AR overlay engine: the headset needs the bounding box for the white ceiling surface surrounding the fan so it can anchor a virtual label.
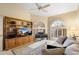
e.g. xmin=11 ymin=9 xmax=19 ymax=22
xmin=19 ymin=3 xmax=78 ymax=16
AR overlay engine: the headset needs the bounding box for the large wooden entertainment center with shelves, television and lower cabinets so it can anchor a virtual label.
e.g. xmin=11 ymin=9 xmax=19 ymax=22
xmin=3 ymin=16 xmax=33 ymax=50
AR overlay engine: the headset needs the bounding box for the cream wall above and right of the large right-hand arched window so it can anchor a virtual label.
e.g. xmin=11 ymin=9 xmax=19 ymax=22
xmin=49 ymin=11 xmax=79 ymax=36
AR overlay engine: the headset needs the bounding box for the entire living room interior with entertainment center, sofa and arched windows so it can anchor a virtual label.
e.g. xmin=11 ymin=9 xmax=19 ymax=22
xmin=0 ymin=3 xmax=79 ymax=55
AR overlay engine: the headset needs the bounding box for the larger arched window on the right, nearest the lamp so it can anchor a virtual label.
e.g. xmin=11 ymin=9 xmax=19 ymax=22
xmin=50 ymin=19 xmax=67 ymax=39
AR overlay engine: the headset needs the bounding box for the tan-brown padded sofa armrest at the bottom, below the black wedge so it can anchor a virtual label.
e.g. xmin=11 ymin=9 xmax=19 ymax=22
xmin=42 ymin=48 xmax=65 ymax=55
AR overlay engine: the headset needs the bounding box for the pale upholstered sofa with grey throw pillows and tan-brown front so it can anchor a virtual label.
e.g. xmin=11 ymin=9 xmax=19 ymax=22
xmin=42 ymin=37 xmax=79 ymax=55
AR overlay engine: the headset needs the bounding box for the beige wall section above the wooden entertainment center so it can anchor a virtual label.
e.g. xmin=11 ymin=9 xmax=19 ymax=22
xmin=0 ymin=3 xmax=31 ymax=20
